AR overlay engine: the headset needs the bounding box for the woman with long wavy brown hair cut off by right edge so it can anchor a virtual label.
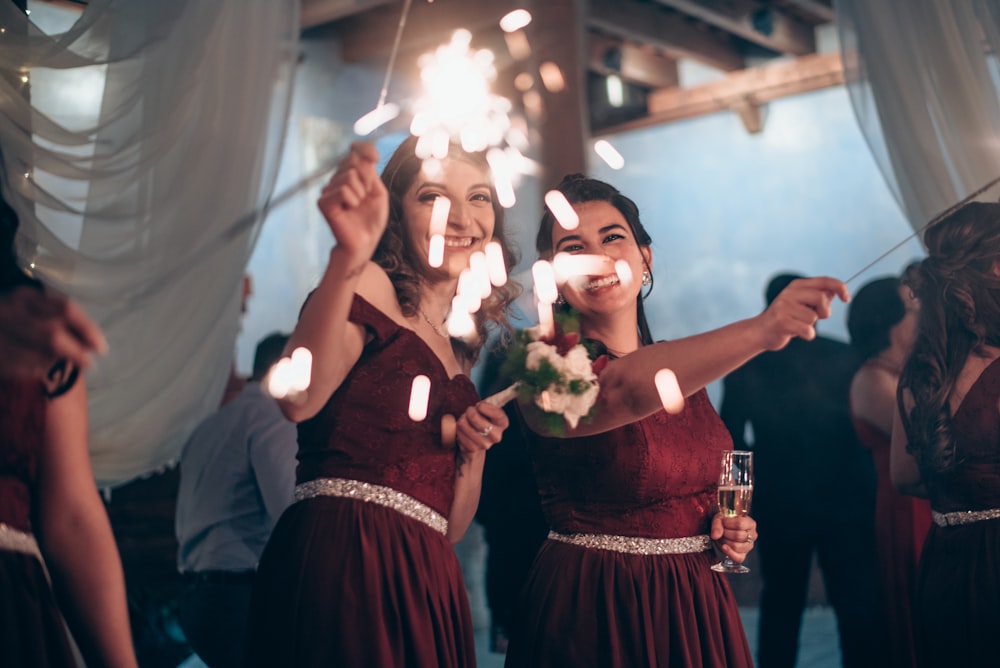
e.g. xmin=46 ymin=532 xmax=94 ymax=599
xmin=890 ymin=202 xmax=1000 ymax=666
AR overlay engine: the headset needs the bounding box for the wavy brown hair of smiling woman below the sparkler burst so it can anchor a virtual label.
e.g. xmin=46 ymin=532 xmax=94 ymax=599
xmin=372 ymin=136 xmax=521 ymax=362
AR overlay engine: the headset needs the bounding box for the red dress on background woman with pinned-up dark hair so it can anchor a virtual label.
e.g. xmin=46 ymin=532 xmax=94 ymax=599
xmin=851 ymin=386 xmax=931 ymax=668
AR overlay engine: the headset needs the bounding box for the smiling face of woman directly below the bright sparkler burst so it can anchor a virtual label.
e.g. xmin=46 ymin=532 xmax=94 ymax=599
xmin=402 ymin=157 xmax=496 ymax=279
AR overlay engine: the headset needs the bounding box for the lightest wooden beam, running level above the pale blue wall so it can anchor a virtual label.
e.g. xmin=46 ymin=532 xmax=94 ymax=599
xmin=600 ymin=53 xmax=844 ymax=134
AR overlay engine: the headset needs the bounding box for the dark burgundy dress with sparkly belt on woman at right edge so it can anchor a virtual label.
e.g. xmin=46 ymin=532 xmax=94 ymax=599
xmin=914 ymin=359 xmax=1000 ymax=667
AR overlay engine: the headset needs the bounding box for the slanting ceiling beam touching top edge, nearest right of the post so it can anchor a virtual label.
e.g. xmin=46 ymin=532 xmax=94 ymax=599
xmin=587 ymin=0 xmax=744 ymax=72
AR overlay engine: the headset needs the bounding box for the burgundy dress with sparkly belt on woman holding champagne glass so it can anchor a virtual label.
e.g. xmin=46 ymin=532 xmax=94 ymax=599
xmin=506 ymin=390 xmax=753 ymax=668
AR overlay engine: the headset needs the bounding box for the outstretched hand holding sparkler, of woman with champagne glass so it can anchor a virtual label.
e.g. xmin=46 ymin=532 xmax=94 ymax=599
xmin=757 ymin=276 xmax=850 ymax=350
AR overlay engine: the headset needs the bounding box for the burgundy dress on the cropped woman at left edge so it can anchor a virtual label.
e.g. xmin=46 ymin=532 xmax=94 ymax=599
xmin=0 ymin=380 xmax=77 ymax=667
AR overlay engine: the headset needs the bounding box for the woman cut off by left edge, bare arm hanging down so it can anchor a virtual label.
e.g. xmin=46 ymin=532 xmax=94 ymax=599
xmin=0 ymin=200 xmax=136 ymax=668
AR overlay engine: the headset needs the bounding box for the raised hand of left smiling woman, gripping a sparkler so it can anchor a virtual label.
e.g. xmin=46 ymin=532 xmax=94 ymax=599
xmin=317 ymin=142 xmax=389 ymax=260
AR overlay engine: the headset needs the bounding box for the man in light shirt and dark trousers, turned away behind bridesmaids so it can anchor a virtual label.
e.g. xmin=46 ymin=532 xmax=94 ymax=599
xmin=175 ymin=333 xmax=297 ymax=668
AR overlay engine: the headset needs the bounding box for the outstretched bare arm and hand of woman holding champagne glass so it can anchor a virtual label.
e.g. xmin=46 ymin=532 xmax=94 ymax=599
xmin=522 ymin=278 xmax=848 ymax=437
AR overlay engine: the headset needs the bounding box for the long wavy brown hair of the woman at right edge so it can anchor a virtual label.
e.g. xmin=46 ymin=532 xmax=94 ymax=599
xmin=898 ymin=202 xmax=1000 ymax=471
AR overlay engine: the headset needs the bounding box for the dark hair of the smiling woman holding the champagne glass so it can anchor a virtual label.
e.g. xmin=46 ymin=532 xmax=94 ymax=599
xmin=535 ymin=174 xmax=653 ymax=346
